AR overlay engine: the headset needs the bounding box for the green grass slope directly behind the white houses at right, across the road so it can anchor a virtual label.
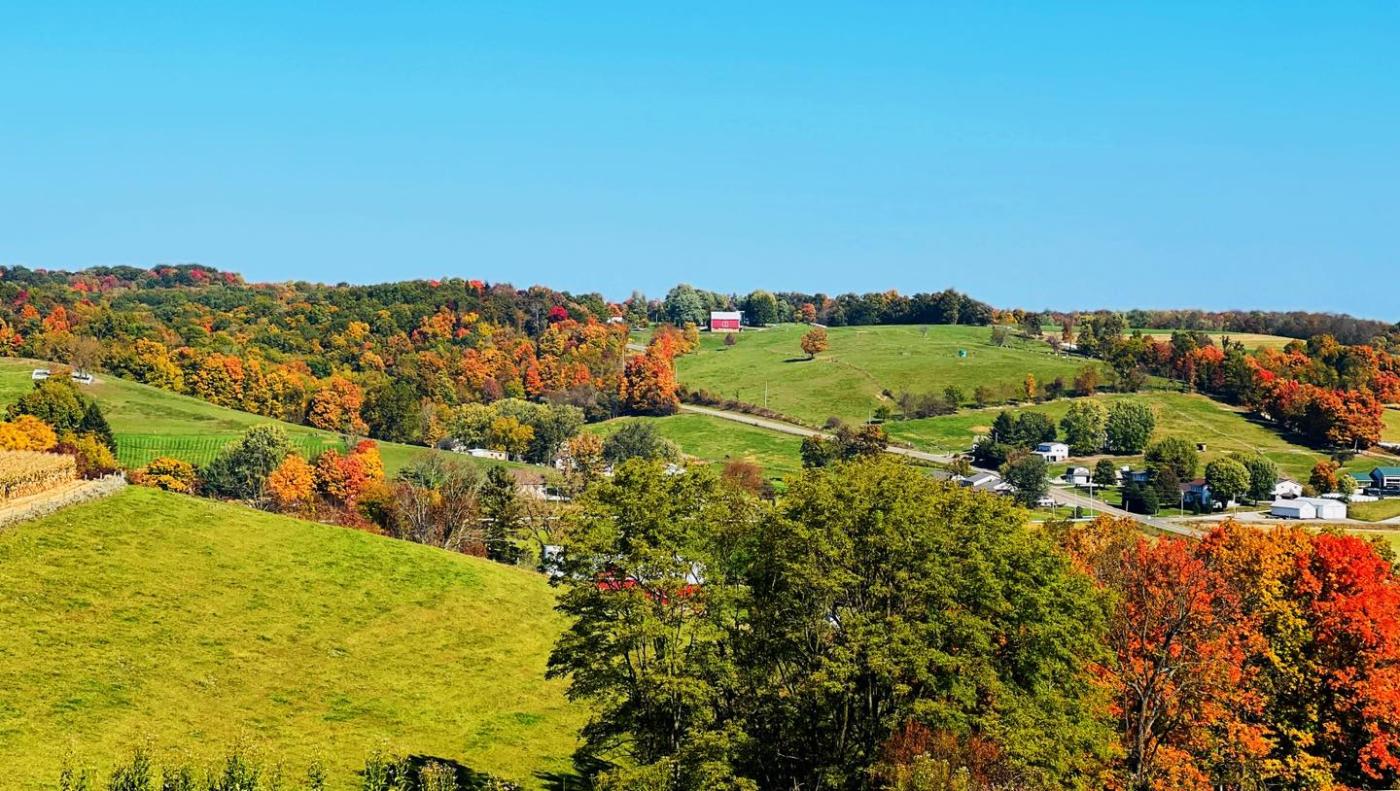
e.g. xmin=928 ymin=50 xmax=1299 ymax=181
xmin=885 ymin=391 xmax=1380 ymax=482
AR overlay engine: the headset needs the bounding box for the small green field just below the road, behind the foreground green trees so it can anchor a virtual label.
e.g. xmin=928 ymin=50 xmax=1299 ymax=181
xmin=585 ymin=412 xmax=802 ymax=479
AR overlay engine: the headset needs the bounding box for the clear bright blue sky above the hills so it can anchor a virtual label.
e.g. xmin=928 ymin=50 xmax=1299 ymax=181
xmin=0 ymin=0 xmax=1400 ymax=321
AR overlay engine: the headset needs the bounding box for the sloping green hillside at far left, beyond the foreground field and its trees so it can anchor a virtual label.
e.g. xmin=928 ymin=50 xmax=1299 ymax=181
xmin=0 ymin=360 xmax=448 ymax=473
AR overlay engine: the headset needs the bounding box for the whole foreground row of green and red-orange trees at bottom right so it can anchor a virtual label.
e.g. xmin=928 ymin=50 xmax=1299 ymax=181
xmin=550 ymin=459 xmax=1400 ymax=791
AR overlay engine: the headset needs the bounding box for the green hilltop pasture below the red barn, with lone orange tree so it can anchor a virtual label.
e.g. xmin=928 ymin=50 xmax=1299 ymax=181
xmin=676 ymin=325 xmax=1098 ymax=423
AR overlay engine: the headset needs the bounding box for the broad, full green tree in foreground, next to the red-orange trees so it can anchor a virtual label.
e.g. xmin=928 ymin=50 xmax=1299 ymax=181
xmin=739 ymin=459 xmax=1106 ymax=788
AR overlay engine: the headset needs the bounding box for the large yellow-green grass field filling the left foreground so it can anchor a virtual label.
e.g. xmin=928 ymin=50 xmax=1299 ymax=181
xmin=0 ymin=487 xmax=584 ymax=790
